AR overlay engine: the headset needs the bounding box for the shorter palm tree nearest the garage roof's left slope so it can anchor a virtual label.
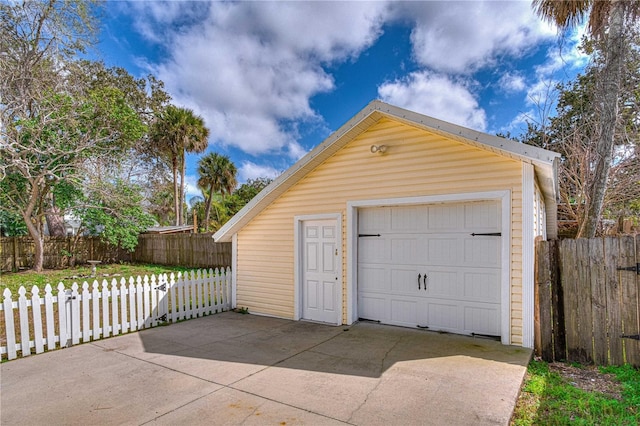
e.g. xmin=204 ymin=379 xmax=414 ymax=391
xmin=198 ymin=152 xmax=238 ymax=229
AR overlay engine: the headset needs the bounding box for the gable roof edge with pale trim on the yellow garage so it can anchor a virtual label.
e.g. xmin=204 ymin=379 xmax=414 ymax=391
xmin=213 ymin=100 xmax=560 ymax=242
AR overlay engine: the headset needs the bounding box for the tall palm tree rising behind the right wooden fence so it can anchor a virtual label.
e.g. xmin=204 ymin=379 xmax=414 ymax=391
xmin=533 ymin=0 xmax=640 ymax=238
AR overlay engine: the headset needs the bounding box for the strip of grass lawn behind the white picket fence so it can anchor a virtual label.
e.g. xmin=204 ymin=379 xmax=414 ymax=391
xmin=0 ymin=263 xmax=193 ymax=295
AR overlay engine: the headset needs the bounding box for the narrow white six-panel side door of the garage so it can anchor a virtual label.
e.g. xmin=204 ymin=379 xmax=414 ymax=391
xmin=302 ymin=219 xmax=342 ymax=324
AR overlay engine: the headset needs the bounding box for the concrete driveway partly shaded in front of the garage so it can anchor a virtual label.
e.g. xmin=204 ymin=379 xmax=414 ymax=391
xmin=0 ymin=312 xmax=531 ymax=425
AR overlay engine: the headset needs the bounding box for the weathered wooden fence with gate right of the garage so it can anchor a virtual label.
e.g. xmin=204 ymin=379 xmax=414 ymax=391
xmin=535 ymin=235 xmax=640 ymax=367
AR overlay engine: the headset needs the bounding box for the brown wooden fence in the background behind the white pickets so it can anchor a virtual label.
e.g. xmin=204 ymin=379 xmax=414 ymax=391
xmin=0 ymin=234 xmax=231 ymax=272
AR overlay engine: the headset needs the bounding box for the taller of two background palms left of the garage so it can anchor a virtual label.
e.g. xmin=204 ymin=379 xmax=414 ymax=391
xmin=151 ymin=105 xmax=209 ymax=225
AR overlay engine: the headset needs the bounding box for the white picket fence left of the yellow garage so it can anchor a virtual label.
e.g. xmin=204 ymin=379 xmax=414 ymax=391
xmin=0 ymin=268 xmax=232 ymax=360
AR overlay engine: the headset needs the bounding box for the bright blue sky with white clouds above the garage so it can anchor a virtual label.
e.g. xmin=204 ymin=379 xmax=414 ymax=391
xmin=95 ymin=1 xmax=588 ymax=199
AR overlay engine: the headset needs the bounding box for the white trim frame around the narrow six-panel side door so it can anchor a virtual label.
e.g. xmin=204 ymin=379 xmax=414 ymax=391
xmin=293 ymin=213 xmax=344 ymax=325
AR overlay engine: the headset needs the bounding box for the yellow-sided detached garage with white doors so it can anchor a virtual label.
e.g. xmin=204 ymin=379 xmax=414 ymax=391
xmin=214 ymin=101 xmax=559 ymax=347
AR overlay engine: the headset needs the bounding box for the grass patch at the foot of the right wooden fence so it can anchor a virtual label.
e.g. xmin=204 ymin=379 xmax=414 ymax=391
xmin=511 ymin=361 xmax=640 ymax=426
